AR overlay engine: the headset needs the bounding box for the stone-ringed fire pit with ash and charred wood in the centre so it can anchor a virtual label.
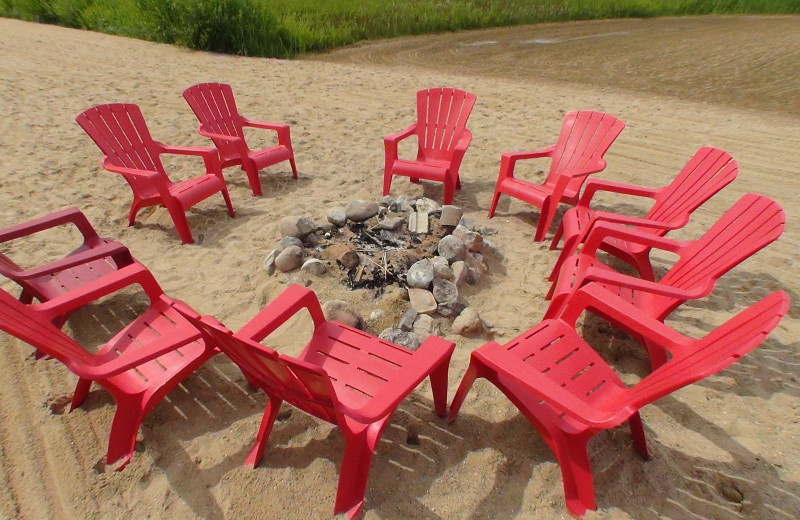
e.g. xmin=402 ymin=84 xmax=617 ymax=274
xmin=264 ymin=196 xmax=502 ymax=348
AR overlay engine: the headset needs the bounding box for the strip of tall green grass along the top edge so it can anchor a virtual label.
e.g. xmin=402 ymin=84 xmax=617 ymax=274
xmin=0 ymin=0 xmax=800 ymax=57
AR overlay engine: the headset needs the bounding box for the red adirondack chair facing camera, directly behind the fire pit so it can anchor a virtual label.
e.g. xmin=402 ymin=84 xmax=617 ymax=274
xmin=383 ymin=87 xmax=476 ymax=204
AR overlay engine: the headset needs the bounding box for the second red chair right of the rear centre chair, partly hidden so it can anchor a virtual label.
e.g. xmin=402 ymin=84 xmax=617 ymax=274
xmin=550 ymin=147 xmax=739 ymax=280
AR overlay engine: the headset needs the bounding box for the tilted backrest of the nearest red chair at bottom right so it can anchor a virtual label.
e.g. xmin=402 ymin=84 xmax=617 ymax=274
xmin=628 ymin=291 xmax=789 ymax=408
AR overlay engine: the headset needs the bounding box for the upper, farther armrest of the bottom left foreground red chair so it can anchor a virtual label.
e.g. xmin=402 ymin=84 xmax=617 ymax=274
xmin=31 ymin=263 xmax=164 ymax=321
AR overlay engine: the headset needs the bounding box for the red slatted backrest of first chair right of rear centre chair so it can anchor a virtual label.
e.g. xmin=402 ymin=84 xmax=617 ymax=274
xmin=545 ymin=110 xmax=625 ymax=193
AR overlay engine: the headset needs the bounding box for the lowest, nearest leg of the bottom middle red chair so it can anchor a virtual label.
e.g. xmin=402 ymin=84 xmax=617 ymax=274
xmin=333 ymin=417 xmax=388 ymax=519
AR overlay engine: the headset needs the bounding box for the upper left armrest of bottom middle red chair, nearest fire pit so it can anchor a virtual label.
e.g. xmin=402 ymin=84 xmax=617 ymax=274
xmin=234 ymin=285 xmax=325 ymax=342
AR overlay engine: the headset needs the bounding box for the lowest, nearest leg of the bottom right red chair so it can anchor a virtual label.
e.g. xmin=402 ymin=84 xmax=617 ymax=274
xmin=553 ymin=433 xmax=597 ymax=516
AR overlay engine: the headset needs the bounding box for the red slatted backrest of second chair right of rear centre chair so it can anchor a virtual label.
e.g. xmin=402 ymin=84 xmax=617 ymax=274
xmin=640 ymin=146 xmax=739 ymax=228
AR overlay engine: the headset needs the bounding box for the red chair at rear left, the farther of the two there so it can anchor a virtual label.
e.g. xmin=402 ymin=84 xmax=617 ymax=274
xmin=183 ymin=83 xmax=297 ymax=196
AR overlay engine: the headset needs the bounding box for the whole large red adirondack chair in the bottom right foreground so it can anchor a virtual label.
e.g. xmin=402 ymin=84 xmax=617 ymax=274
xmin=449 ymin=283 xmax=789 ymax=515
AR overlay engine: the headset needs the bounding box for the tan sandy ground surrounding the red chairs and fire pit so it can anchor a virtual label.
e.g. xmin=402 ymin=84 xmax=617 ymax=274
xmin=0 ymin=17 xmax=800 ymax=519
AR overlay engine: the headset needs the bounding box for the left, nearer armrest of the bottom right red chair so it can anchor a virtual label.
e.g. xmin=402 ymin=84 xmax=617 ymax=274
xmin=472 ymin=341 xmax=636 ymax=429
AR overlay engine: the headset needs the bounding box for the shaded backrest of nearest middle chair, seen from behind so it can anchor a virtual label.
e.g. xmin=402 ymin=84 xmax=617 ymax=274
xmin=184 ymin=306 xmax=339 ymax=424
